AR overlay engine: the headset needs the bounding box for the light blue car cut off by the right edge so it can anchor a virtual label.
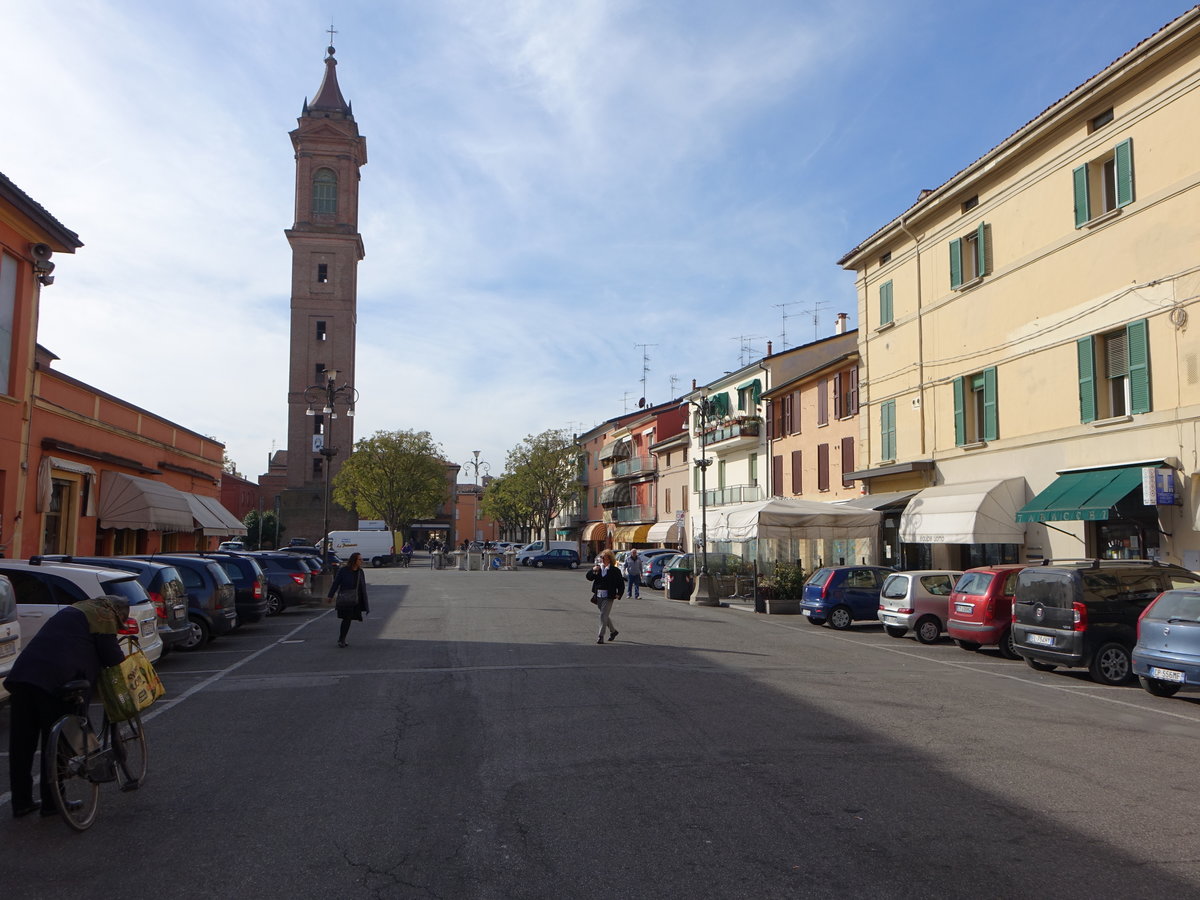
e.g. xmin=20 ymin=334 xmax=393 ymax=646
xmin=1133 ymin=588 xmax=1200 ymax=697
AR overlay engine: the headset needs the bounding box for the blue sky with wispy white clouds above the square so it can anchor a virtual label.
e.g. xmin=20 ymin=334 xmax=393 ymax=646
xmin=0 ymin=0 xmax=1190 ymax=478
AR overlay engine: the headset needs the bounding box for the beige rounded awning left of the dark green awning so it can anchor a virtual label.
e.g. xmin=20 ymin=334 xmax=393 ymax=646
xmin=900 ymin=478 xmax=1027 ymax=544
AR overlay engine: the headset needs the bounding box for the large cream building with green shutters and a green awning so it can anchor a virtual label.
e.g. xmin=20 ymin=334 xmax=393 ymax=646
xmin=840 ymin=10 xmax=1200 ymax=569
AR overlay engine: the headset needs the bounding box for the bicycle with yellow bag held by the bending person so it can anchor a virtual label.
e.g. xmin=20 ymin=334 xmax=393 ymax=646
xmin=42 ymin=679 xmax=146 ymax=832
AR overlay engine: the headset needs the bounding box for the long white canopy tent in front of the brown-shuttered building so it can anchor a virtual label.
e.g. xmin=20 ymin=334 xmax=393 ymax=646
xmin=695 ymin=497 xmax=880 ymax=542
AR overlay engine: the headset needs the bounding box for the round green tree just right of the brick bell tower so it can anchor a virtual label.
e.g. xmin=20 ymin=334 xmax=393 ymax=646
xmin=334 ymin=431 xmax=449 ymax=547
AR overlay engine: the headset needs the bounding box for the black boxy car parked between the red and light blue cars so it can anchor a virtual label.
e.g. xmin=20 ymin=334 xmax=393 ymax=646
xmin=1012 ymin=559 xmax=1200 ymax=684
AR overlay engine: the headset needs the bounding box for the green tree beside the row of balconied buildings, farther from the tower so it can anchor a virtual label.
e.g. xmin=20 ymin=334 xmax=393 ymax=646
xmin=505 ymin=428 xmax=583 ymax=540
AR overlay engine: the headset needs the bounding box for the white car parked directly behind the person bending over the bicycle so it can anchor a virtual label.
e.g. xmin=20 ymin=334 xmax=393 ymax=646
xmin=0 ymin=557 xmax=162 ymax=662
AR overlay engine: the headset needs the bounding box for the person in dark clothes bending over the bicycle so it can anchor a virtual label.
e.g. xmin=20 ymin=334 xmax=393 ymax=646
xmin=4 ymin=594 xmax=130 ymax=818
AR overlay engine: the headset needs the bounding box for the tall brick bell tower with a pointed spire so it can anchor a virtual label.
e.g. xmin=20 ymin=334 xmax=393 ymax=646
xmin=280 ymin=47 xmax=367 ymax=540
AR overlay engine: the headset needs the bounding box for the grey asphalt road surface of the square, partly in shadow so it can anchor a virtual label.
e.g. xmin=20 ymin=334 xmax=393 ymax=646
xmin=0 ymin=568 xmax=1200 ymax=900
